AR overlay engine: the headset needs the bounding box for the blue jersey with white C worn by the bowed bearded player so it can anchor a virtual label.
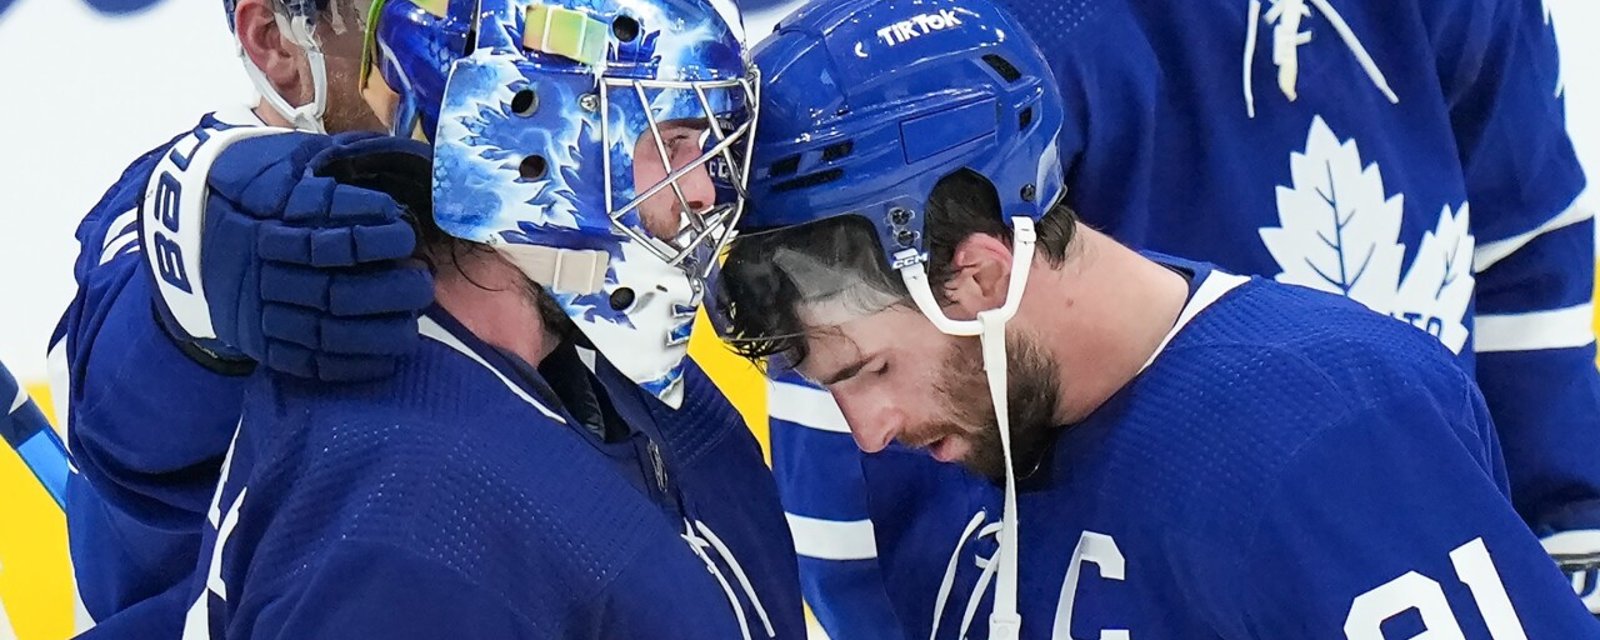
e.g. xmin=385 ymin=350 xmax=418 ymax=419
xmin=902 ymin=262 xmax=1600 ymax=640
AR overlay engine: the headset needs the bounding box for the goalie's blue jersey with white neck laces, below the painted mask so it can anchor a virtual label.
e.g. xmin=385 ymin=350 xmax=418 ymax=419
xmin=184 ymin=309 xmax=805 ymax=638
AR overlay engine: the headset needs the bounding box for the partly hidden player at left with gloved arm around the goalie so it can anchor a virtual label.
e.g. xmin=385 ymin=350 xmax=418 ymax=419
xmin=51 ymin=0 xmax=432 ymax=626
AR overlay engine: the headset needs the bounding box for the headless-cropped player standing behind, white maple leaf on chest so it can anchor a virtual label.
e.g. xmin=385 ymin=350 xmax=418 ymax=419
xmin=770 ymin=0 xmax=1600 ymax=637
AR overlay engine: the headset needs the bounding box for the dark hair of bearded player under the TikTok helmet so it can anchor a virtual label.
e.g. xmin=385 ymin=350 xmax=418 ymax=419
xmin=717 ymin=170 xmax=1078 ymax=365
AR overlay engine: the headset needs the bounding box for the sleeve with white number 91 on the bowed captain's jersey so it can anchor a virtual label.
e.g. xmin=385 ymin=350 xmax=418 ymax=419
xmin=1192 ymin=374 xmax=1600 ymax=640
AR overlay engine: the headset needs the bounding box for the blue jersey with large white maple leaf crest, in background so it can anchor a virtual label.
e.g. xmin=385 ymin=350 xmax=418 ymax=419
xmin=1088 ymin=0 xmax=1600 ymax=533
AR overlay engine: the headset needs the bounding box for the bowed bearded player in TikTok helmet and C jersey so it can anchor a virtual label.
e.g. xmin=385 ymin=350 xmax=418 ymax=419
xmin=718 ymin=0 xmax=1600 ymax=638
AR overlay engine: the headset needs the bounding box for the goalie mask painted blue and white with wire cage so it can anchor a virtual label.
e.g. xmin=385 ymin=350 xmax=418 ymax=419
xmin=363 ymin=0 xmax=760 ymax=406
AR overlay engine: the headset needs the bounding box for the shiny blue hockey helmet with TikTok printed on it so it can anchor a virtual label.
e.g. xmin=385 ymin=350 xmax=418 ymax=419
xmin=741 ymin=0 xmax=1064 ymax=267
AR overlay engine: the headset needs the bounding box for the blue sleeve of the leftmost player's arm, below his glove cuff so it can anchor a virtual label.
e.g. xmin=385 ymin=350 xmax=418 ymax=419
xmin=51 ymin=117 xmax=248 ymax=619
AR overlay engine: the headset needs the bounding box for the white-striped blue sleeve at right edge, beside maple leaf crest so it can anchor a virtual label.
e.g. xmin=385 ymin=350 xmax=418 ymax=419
xmin=1440 ymin=0 xmax=1600 ymax=531
